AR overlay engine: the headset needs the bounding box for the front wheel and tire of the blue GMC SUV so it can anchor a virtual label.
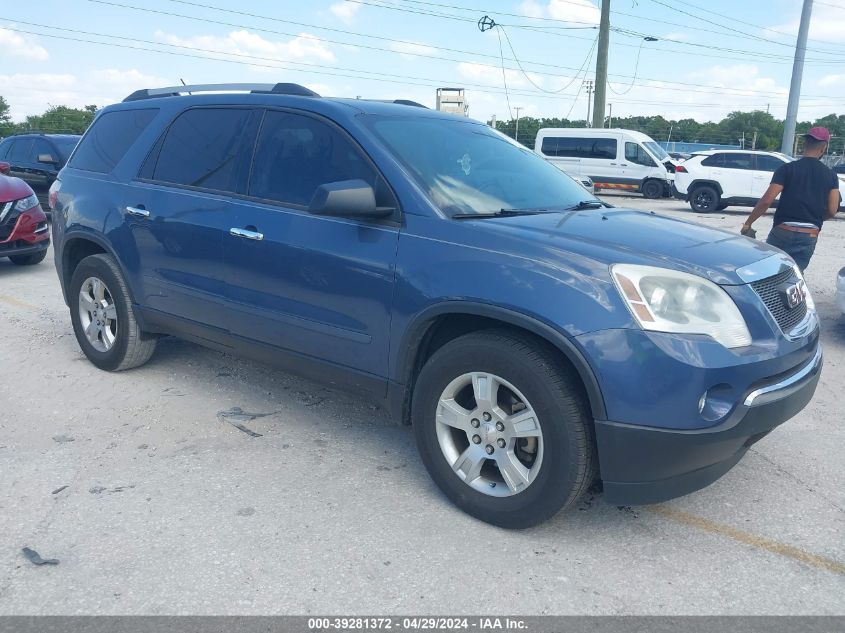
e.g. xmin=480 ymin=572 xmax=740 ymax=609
xmin=411 ymin=330 xmax=596 ymax=528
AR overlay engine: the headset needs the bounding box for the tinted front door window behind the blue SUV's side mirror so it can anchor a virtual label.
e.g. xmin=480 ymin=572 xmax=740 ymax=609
xmin=249 ymin=111 xmax=380 ymax=206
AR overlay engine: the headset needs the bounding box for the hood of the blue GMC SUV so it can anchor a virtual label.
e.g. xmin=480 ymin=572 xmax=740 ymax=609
xmin=472 ymin=208 xmax=780 ymax=285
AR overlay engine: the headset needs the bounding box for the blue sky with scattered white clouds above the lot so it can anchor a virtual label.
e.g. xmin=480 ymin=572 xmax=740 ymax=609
xmin=0 ymin=0 xmax=845 ymax=133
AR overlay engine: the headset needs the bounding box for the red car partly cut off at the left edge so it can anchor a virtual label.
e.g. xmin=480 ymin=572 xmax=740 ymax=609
xmin=0 ymin=162 xmax=50 ymax=266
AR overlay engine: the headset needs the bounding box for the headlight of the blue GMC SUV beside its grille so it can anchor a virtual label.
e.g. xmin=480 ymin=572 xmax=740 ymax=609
xmin=611 ymin=264 xmax=751 ymax=347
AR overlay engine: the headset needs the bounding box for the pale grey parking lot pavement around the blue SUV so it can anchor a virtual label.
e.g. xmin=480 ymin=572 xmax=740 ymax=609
xmin=0 ymin=196 xmax=845 ymax=615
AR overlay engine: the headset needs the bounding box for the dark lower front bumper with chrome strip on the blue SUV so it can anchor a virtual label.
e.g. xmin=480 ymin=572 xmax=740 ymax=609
xmin=596 ymin=345 xmax=822 ymax=505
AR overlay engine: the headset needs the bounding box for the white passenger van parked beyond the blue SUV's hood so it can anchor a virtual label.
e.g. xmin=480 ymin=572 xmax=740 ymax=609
xmin=534 ymin=127 xmax=675 ymax=198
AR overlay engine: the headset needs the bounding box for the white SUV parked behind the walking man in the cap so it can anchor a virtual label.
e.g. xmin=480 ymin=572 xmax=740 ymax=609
xmin=673 ymin=150 xmax=845 ymax=213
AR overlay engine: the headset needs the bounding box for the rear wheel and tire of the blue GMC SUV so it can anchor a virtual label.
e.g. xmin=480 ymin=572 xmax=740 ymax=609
xmin=68 ymin=254 xmax=156 ymax=371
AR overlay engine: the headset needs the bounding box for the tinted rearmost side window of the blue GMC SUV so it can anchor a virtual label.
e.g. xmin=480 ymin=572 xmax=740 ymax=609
xmin=70 ymin=109 xmax=158 ymax=174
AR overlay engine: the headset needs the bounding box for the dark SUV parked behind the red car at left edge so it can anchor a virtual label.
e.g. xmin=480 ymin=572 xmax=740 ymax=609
xmin=0 ymin=133 xmax=82 ymax=213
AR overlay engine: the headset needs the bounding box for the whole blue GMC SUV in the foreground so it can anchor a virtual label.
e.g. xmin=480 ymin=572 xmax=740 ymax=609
xmin=51 ymin=84 xmax=822 ymax=528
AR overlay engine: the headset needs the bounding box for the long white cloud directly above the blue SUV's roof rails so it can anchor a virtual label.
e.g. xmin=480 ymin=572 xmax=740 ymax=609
xmin=155 ymin=29 xmax=335 ymax=72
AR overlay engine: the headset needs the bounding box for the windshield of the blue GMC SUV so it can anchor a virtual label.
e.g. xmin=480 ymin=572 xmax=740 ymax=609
xmin=368 ymin=116 xmax=597 ymax=217
